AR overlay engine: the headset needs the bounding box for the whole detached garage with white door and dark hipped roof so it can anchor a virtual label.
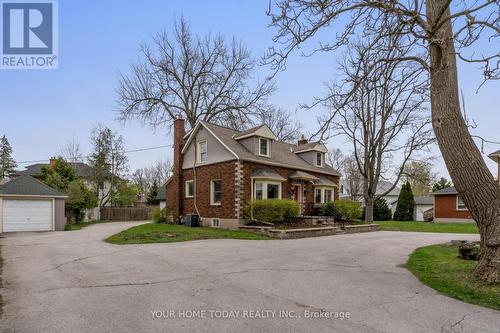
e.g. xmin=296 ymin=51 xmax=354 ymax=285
xmin=0 ymin=176 xmax=66 ymax=232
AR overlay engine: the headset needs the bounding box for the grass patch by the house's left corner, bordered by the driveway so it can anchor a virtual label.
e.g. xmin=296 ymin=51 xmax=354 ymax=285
xmin=106 ymin=223 xmax=272 ymax=244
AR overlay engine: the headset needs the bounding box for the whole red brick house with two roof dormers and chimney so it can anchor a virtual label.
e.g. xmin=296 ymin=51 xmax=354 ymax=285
xmin=165 ymin=118 xmax=340 ymax=228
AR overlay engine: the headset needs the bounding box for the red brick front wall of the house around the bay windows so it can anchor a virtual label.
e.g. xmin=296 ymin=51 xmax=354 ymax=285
xmin=242 ymin=162 xmax=339 ymax=215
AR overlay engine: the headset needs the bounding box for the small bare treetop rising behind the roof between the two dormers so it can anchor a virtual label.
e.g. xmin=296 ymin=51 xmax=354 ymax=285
xmin=258 ymin=106 xmax=301 ymax=143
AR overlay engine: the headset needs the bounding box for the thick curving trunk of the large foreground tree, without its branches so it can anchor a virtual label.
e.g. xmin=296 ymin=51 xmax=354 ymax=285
xmin=427 ymin=0 xmax=500 ymax=282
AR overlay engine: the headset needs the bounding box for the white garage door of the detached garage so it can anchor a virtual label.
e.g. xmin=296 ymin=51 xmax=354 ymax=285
xmin=3 ymin=200 xmax=52 ymax=232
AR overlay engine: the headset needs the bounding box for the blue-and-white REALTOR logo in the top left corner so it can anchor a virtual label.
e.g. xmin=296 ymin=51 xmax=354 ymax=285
xmin=0 ymin=0 xmax=58 ymax=69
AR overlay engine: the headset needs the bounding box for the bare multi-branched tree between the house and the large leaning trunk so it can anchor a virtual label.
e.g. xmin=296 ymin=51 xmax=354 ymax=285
xmin=318 ymin=34 xmax=432 ymax=222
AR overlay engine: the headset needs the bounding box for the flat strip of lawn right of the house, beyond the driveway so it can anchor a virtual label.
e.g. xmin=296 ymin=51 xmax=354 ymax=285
xmin=374 ymin=221 xmax=479 ymax=234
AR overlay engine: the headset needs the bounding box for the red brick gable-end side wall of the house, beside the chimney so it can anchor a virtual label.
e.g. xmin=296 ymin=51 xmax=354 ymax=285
xmin=180 ymin=161 xmax=236 ymax=219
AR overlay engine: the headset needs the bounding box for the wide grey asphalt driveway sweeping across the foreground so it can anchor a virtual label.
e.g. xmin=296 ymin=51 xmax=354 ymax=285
xmin=0 ymin=223 xmax=500 ymax=333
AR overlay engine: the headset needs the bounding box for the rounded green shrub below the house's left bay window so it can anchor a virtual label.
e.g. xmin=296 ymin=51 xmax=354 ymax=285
xmin=243 ymin=199 xmax=300 ymax=223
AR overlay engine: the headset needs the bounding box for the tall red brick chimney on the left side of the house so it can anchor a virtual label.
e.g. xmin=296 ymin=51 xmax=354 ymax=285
xmin=165 ymin=114 xmax=185 ymax=219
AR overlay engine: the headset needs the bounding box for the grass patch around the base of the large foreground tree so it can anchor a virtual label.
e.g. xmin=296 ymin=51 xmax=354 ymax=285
xmin=408 ymin=245 xmax=500 ymax=310
